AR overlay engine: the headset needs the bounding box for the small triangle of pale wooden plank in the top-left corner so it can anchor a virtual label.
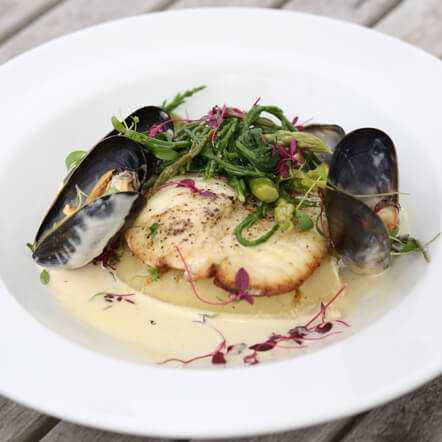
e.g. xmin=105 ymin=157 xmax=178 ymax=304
xmin=0 ymin=0 xmax=62 ymax=41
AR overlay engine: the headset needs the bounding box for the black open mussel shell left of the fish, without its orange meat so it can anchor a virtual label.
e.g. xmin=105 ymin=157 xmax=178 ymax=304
xmin=33 ymin=136 xmax=154 ymax=268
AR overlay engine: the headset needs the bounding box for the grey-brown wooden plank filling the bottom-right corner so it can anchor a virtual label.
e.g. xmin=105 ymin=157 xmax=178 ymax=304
xmin=342 ymin=376 xmax=442 ymax=442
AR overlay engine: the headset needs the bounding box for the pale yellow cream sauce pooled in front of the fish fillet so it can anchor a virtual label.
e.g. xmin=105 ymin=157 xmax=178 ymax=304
xmin=45 ymin=250 xmax=376 ymax=367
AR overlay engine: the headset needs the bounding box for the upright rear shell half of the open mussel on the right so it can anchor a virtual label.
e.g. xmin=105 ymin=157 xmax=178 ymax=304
xmin=328 ymin=128 xmax=398 ymax=210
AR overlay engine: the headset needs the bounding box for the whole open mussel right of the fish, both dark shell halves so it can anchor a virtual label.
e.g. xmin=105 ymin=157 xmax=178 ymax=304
xmin=324 ymin=128 xmax=399 ymax=273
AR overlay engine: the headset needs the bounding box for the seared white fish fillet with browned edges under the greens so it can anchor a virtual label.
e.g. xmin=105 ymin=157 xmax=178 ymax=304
xmin=126 ymin=176 xmax=328 ymax=295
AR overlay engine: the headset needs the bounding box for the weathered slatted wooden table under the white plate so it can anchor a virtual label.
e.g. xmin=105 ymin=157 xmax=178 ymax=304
xmin=0 ymin=0 xmax=442 ymax=442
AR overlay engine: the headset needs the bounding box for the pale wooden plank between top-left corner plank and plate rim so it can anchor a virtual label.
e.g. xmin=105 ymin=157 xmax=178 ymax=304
xmin=0 ymin=0 xmax=176 ymax=63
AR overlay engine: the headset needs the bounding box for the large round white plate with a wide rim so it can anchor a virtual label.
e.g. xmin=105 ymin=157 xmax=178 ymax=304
xmin=0 ymin=9 xmax=442 ymax=438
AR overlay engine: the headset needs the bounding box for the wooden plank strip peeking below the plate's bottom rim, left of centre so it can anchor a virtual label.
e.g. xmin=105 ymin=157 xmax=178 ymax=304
xmin=41 ymin=422 xmax=171 ymax=442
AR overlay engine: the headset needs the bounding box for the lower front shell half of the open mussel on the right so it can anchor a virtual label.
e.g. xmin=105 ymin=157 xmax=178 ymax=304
xmin=324 ymin=190 xmax=391 ymax=274
